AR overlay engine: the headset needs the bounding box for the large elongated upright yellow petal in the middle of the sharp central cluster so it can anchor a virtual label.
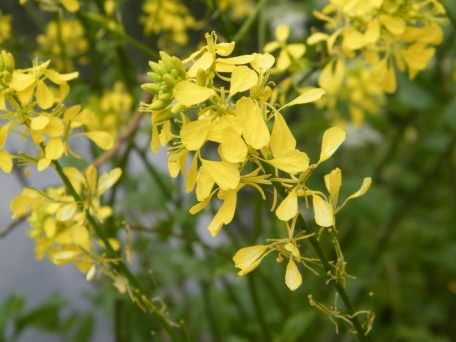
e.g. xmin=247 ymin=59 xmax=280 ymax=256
xmin=236 ymin=97 xmax=271 ymax=150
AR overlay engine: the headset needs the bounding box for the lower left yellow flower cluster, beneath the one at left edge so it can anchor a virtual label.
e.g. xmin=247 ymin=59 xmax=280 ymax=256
xmin=11 ymin=166 xmax=122 ymax=279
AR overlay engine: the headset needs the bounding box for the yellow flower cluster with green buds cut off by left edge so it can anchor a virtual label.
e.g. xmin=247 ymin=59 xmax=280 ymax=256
xmin=0 ymin=51 xmax=113 ymax=173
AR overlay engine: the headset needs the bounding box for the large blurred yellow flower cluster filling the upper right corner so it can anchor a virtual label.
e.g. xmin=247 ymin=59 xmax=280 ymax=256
xmin=307 ymin=0 xmax=446 ymax=124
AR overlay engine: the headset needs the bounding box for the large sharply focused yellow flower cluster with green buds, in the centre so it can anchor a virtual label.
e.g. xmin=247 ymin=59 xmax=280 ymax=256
xmin=142 ymin=34 xmax=371 ymax=290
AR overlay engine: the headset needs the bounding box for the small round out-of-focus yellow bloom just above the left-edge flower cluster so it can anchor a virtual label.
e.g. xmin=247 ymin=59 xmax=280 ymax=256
xmin=37 ymin=19 xmax=88 ymax=71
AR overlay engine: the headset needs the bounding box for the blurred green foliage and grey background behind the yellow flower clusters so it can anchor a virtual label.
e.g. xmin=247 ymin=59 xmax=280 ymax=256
xmin=0 ymin=0 xmax=456 ymax=342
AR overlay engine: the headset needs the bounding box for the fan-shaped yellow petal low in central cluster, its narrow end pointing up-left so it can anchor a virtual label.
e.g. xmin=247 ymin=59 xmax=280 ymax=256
xmin=203 ymin=160 xmax=241 ymax=190
